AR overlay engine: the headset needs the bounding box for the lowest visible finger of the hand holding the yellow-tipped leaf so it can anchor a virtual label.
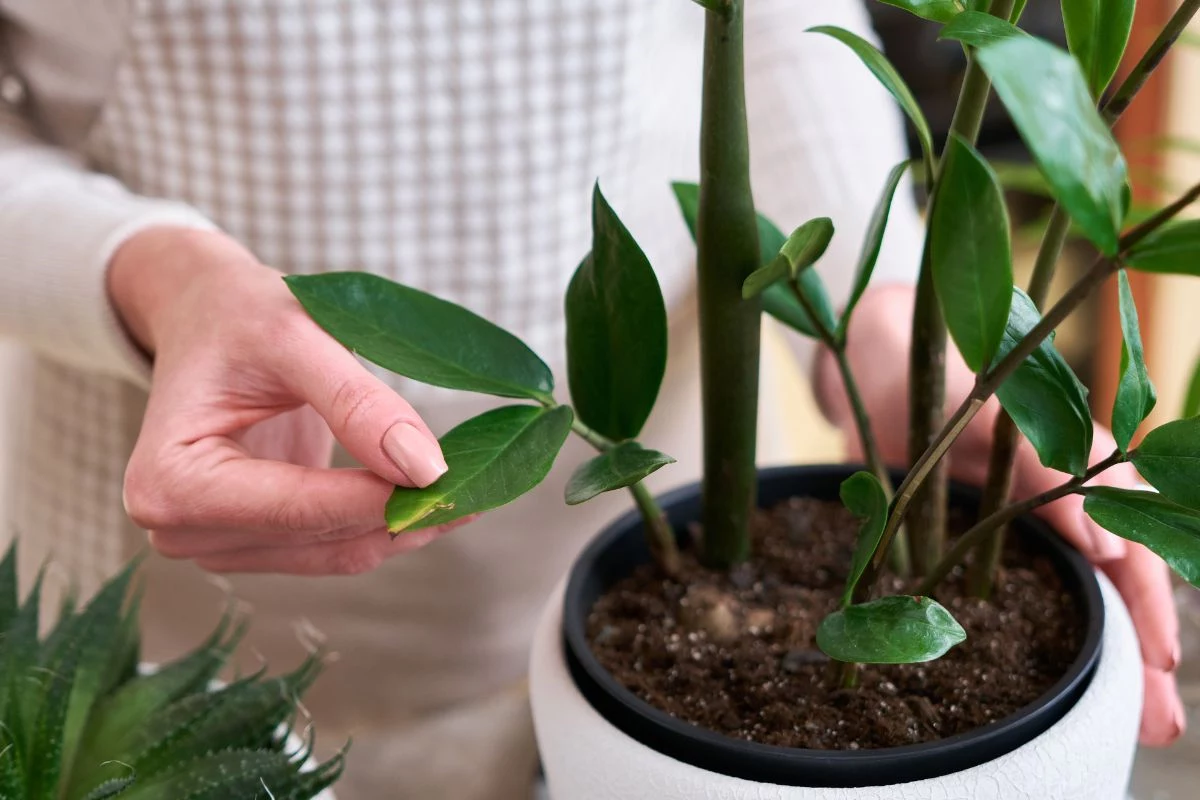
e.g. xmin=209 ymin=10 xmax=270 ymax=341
xmin=197 ymin=525 xmax=457 ymax=576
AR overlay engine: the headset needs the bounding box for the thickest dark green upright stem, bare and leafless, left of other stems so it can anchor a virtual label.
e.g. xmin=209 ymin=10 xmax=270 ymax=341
xmin=696 ymin=0 xmax=762 ymax=567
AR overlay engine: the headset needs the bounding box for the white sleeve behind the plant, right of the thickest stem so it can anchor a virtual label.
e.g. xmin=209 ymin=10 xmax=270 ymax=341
xmin=745 ymin=0 xmax=923 ymax=362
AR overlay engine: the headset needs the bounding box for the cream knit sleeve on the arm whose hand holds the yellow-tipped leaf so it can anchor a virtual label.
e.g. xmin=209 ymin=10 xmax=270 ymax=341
xmin=0 ymin=94 xmax=212 ymax=386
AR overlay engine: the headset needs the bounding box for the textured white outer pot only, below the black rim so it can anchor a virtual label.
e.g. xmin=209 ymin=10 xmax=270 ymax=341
xmin=529 ymin=563 xmax=1142 ymax=800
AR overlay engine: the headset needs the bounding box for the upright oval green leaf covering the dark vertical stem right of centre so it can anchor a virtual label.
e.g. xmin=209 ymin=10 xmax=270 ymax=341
xmin=929 ymin=134 xmax=1013 ymax=372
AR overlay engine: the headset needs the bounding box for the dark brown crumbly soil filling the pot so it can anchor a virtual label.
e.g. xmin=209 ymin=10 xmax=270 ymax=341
xmin=588 ymin=499 xmax=1084 ymax=750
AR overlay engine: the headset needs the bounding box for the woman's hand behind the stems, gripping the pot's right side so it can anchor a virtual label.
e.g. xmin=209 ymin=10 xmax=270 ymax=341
xmin=814 ymin=287 xmax=1186 ymax=745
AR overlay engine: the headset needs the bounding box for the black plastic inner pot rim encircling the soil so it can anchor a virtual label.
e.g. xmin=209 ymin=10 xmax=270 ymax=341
xmin=563 ymin=464 xmax=1104 ymax=788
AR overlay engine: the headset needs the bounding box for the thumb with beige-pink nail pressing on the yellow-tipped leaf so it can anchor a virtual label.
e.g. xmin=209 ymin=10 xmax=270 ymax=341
xmin=282 ymin=325 xmax=446 ymax=487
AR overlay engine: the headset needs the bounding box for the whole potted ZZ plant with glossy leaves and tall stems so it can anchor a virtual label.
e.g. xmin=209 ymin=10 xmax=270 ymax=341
xmin=287 ymin=0 xmax=1200 ymax=685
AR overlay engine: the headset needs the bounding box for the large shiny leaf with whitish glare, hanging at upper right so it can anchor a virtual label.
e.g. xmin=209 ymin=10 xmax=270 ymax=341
xmin=976 ymin=36 xmax=1126 ymax=255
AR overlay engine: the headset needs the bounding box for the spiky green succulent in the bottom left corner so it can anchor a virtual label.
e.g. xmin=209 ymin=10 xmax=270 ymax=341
xmin=0 ymin=545 xmax=343 ymax=800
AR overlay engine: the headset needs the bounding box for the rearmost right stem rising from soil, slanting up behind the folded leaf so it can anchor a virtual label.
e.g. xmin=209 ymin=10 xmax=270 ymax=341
xmin=967 ymin=204 xmax=1070 ymax=599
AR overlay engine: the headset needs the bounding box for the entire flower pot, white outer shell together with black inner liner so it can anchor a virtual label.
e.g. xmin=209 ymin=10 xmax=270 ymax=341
xmin=530 ymin=465 xmax=1142 ymax=800
